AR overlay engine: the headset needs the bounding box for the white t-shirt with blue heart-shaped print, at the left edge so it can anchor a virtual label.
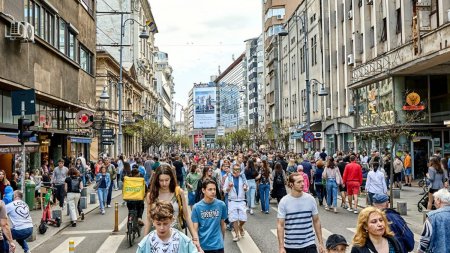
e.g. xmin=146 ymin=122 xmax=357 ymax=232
xmin=6 ymin=200 xmax=33 ymax=230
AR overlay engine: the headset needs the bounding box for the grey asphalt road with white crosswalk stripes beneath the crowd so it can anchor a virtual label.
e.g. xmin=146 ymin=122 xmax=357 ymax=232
xmin=29 ymin=190 xmax=421 ymax=253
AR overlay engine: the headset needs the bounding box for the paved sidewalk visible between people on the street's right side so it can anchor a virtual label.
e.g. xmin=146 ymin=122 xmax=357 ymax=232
xmin=358 ymin=180 xmax=426 ymax=234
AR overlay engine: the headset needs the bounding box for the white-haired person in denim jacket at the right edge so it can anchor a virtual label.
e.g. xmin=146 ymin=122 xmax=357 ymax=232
xmin=417 ymin=188 xmax=450 ymax=253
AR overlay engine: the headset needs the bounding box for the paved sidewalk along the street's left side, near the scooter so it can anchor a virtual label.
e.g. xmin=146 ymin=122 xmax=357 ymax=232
xmin=28 ymin=184 xmax=122 ymax=251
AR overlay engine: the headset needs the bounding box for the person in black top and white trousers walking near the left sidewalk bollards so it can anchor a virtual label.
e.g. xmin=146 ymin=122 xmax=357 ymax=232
xmin=64 ymin=167 xmax=84 ymax=227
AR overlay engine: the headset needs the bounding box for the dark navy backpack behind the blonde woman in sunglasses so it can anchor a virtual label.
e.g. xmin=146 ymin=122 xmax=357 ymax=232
xmin=386 ymin=209 xmax=414 ymax=253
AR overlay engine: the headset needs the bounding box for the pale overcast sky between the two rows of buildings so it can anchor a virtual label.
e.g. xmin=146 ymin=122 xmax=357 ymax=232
xmin=149 ymin=0 xmax=262 ymax=110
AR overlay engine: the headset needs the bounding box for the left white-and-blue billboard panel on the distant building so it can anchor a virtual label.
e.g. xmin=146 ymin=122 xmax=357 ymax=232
xmin=194 ymin=87 xmax=216 ymax=128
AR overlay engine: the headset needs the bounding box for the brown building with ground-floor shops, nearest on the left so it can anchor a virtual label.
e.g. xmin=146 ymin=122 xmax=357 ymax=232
xmin=0 ymin=0 xmax=96 ymax=170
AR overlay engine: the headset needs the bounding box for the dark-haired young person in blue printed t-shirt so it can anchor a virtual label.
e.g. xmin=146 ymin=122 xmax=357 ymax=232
xmin=191 ymin=178 xmax=227 ymax=253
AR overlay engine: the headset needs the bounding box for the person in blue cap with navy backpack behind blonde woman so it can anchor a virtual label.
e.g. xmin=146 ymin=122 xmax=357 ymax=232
xmin=372 ymin=194 xmax=414 ymax=253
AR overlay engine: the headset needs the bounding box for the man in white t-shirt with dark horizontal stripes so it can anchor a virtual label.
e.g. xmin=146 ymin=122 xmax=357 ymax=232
xmin=277 ymin=172 xmax=325 ymax=253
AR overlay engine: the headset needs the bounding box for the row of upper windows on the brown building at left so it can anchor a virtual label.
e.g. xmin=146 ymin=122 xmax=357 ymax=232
xmin=24 ymin=0 xmax=94 ymax=74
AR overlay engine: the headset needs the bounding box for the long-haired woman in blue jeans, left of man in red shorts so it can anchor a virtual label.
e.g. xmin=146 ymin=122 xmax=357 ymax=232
xmin=322 ymin=157 xmax=342 ymax=213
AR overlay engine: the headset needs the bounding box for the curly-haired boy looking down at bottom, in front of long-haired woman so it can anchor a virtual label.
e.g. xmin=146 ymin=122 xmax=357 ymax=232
xmin=136 ymin=201 xmax=198 ymax=253
